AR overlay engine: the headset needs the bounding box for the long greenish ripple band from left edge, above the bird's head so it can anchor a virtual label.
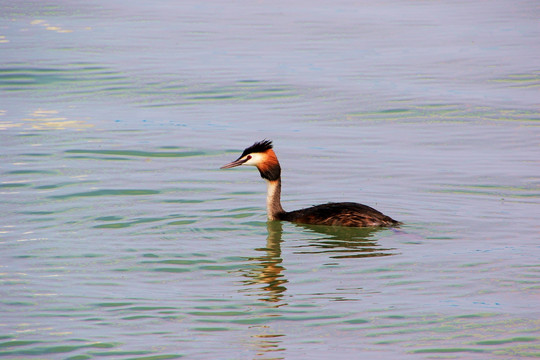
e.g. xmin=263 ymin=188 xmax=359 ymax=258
xmin=0 ymin=63 xmax=299 ymax=107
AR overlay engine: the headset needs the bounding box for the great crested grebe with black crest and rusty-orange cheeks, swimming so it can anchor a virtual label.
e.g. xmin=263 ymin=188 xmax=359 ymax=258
xmin=221 ymin=140 xmax=399 ymax=227
